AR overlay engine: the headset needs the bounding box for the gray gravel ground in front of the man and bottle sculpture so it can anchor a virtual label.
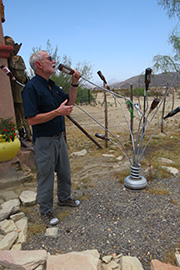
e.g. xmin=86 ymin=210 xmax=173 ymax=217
xmin=23 ymin=177 xmax=180 ymax=270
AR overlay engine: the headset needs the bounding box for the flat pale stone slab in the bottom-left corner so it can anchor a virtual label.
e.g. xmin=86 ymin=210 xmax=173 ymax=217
xmin=0 ymin=250 xmax=47 ymax=270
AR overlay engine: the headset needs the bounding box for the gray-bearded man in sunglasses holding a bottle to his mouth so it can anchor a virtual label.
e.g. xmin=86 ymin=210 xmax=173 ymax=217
xmin=22 ymin=51 xmax=81 ymax=225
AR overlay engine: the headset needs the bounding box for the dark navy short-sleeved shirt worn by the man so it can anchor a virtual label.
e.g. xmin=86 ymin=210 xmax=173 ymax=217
xmin=22 ymin=75 xmax=69 ymax=142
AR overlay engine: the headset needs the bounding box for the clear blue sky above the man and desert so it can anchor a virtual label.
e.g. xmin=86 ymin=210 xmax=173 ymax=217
xmin=2 ymin=0 xmax=177 ymax=82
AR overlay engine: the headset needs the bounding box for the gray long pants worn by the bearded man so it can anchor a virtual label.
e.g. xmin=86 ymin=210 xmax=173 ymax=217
xmin=34 ymin=135 xmax=71 ymax=214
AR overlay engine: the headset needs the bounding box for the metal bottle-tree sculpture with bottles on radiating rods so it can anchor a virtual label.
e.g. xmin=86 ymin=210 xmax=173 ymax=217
xmin=58 ymin=64 xmax=180 ymax=190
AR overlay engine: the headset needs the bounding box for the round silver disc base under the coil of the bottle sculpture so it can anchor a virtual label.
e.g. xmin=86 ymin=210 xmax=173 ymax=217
xmin=124 ymin=175 xmax=147 ymax=190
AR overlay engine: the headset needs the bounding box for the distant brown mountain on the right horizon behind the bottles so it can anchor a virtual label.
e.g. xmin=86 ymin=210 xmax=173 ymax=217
xmin=110 ymin=72 xmax=180 ymax=89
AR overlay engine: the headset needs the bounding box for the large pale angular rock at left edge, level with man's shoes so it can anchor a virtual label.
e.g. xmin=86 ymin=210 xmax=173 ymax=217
xmin=0 ymin=199 xmax=20 ymax=221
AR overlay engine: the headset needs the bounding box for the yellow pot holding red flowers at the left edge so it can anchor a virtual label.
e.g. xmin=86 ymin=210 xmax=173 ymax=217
xmin=0 ymin=135 xmax=21 ymax=162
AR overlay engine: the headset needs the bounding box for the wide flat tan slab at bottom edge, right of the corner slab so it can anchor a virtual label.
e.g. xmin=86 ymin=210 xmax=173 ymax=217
xmin=47 ymin=250 xmax=100 ymax=270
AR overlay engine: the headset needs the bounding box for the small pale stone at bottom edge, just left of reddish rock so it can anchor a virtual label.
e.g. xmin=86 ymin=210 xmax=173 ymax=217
xmin=120 ymin=256 xmax=143 ymax=270
